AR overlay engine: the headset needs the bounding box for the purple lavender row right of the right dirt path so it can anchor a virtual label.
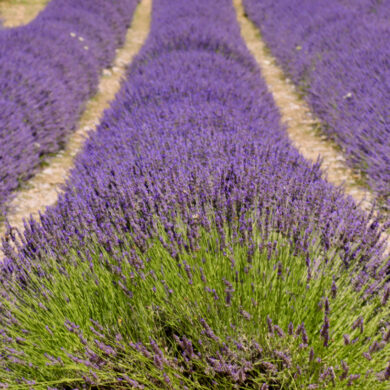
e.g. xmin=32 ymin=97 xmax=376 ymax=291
xmin=244 ymin=0 xmax=390 ymax=209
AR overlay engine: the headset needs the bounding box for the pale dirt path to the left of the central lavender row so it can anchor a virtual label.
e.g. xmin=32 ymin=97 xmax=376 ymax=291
xmin=0 ymin=0 xmax=152 ymax=241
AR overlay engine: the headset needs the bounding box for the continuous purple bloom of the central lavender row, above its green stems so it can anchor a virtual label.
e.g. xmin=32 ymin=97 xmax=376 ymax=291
xmin=4 ymin=0 xmax=382 ymax=276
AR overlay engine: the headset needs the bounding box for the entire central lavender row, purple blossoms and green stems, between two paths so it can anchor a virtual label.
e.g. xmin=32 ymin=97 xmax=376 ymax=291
xmin=0 ymin=0 xmax=390 ymax=390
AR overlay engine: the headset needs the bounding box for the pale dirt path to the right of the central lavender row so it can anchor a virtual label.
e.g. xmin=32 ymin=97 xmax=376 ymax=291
xmin=234 ymin=0 xmax=373 ymax=209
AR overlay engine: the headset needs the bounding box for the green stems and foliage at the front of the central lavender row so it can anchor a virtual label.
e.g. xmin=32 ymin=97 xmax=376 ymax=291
xmin=0 ymin=215 xmax=390 ymax=389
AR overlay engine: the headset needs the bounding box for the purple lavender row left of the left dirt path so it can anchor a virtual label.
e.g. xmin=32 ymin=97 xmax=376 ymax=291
xmin=0 ymin=0 xmax=137 ymax=217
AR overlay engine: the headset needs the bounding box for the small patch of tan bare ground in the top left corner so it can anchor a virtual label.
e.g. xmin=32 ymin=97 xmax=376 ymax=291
xmin=0 ymin=0 xmax=49 ymax=27
